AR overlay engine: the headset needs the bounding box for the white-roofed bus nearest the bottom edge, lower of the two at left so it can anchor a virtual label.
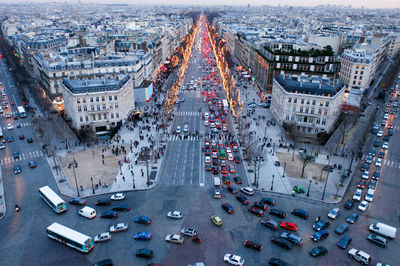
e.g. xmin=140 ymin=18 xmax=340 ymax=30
xmin=46 ymin=223 xmax=94 ymax=253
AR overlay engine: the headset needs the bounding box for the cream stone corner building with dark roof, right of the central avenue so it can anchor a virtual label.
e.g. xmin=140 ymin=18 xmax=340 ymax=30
xmin=271 ymin=75 xmax=345 ymax=137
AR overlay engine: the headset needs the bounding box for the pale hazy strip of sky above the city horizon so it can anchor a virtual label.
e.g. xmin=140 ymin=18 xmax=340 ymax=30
xmin=0 ymin=0 xmax=400 ymax=8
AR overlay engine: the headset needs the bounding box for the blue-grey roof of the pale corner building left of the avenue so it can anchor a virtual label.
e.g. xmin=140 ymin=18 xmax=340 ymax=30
xmin=63 ymin=75 xmax=131 ymax=94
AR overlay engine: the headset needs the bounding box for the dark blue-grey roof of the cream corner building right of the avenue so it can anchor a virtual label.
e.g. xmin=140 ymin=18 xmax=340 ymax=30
xmin=275 ymin=75 xmax=344 ymax=97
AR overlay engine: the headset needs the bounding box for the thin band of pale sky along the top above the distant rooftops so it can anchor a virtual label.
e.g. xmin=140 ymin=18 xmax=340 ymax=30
xmin=0 ymin=0 xmax=400 ymax=9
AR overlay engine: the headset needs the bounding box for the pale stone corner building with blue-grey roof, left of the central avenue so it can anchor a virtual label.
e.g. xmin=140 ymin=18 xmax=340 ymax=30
xmin=61 ymin=75 xmax=135 ymax=135
